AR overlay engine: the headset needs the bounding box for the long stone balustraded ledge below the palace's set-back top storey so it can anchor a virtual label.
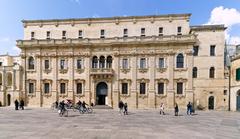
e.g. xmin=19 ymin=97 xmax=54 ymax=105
xmin=17 ymin=34 xmax=197 ymax=48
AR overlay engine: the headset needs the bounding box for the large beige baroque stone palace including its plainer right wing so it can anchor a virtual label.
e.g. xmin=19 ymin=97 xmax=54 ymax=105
xmin=0 ymin=14 xmax=229 ymax=110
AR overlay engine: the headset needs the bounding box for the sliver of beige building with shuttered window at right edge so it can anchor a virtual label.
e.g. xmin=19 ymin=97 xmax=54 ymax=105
xmin=230 ymin=45 xmax=240 ymax=111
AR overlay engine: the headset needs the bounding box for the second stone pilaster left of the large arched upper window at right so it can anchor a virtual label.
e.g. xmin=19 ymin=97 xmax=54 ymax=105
xmin=148 ymin=56 xmax=156 ymax=108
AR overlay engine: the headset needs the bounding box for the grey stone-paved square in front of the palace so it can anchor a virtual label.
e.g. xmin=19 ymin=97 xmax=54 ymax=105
xmin=0 ymin=107 xmax=240 ymax=139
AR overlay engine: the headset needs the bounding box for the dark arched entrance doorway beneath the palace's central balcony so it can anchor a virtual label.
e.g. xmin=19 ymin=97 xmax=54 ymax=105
xmin=96 ymin=82 xmax=108 ymax=105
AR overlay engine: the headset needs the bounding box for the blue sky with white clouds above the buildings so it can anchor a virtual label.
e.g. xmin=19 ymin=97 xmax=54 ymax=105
xmin=0 ymin=0 xmax=240 ymax=55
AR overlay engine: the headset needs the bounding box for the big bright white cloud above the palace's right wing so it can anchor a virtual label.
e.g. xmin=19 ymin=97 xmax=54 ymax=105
xmin=206 ymin=6 xmax=240 ymax=44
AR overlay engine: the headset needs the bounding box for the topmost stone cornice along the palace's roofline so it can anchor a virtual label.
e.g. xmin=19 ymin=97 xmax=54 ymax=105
xmin=22 ymin=14 xmax=191 ymax=27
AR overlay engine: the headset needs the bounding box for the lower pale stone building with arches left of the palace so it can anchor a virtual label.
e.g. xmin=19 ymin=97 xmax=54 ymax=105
xmin=0 ymin=54 xmax=23 ymax=106
